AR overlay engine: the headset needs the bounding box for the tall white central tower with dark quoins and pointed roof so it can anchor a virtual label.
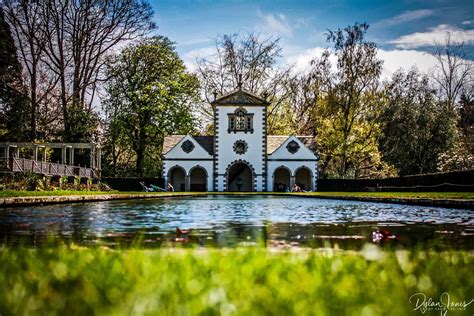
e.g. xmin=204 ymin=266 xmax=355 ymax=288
xmin=211 ymin=84 xmax=270 ymax=192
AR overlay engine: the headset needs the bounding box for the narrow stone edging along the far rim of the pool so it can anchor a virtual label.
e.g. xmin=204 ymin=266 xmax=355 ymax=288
xmin=0 ymin=192 xmax=474 ymax=210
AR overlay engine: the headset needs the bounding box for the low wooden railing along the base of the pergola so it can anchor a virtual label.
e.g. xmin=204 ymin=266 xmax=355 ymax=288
xmin=0 ymin=157 xmax=95 ymax=178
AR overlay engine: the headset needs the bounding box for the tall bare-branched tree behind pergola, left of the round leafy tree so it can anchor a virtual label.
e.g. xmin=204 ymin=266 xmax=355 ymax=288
xmin=39 ymin=0 xmax=154 ymax=141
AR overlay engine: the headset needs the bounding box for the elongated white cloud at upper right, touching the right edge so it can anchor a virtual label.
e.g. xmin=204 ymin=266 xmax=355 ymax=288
xmin=388 ymin=24 xmax=474 ymax=49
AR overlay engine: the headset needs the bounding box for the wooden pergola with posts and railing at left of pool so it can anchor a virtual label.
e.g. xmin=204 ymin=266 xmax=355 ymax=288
xmin=0 ymin=142 xmax=101 ymax=178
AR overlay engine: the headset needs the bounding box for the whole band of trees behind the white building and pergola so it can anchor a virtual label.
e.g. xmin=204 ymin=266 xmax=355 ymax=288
xmin=0 ymin=6 xmax=474 ymax=178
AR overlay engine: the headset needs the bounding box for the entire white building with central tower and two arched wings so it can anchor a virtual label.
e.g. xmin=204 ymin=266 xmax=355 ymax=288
xmin=163 ymin=89 xmax=318 ymax=192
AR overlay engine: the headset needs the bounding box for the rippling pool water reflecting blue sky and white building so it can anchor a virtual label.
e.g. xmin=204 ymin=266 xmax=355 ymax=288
xmin=0 ymin=196 xmax=474 ymax=250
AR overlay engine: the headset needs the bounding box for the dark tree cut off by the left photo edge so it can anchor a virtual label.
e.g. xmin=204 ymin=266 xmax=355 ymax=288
xmin=0 ymin=8 xmax=30 ymax=141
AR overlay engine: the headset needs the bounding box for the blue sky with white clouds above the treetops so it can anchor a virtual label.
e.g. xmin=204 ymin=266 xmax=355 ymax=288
xmin=151 ymin=0 xmax=474 ymax=74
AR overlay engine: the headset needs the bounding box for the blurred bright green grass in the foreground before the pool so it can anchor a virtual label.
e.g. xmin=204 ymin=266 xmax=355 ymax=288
xmin=0 ymin=245 xmax=474 ymax=315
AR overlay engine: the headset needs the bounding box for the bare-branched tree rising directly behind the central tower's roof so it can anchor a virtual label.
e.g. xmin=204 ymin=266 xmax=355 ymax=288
xmin=197 ymin=33 xmax=289 ymax=132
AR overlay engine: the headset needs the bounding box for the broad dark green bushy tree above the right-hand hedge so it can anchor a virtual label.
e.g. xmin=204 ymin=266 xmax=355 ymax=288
xmin=380 ymin=70 xmax=456 ymax=175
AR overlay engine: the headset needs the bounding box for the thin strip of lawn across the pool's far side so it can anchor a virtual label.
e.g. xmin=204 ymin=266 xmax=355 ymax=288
xmin=0 ymin=190 xmax=474 ymax=200
